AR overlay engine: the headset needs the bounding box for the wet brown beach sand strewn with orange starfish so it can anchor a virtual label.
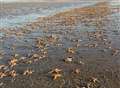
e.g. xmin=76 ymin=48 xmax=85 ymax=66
xmin=0 ymin=2 xmax=120 ymax=88
